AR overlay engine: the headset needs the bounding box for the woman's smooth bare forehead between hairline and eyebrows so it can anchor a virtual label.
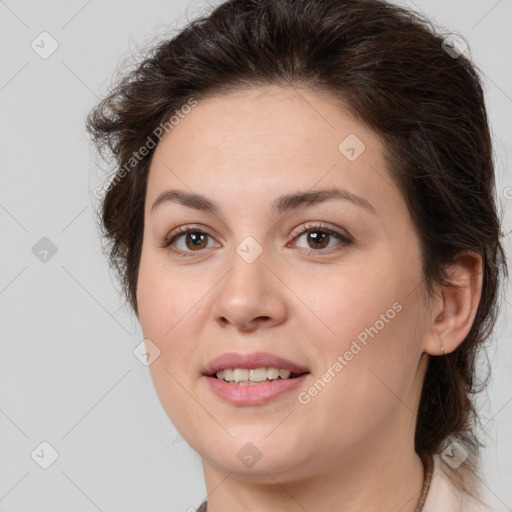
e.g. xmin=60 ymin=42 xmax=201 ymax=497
xmin=147 ymin=86 xmax=404 ymax=218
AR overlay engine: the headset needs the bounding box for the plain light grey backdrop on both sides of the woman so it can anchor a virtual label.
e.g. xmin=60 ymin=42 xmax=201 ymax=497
xmin=0 ymin=0 xmax=512 ymax=512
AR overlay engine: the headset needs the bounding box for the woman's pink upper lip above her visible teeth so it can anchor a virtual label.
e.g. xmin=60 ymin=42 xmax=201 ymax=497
xmin=203 ymin=352 xmax=309 ymax=375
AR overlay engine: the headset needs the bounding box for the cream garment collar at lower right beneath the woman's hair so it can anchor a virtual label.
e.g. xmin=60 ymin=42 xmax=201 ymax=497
xmin=422 ymin=455 xmax=495 ymax=512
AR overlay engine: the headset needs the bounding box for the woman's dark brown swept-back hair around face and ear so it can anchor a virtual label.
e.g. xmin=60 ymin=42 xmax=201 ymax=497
xmin=87 ymin=0 xmax=508 ymax=492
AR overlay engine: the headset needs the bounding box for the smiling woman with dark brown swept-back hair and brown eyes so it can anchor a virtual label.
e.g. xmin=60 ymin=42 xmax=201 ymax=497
xmin=88 ymin=0 xmax=506 ymax=512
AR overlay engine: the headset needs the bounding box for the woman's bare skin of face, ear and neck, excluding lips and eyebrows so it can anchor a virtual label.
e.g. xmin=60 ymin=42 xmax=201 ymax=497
xmin=137 ymin=86 xmax=482 ymax=512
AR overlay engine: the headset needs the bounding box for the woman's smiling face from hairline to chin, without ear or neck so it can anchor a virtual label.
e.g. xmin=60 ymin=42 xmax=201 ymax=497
xmin=137 ymin=86 xmax=427 ymax=481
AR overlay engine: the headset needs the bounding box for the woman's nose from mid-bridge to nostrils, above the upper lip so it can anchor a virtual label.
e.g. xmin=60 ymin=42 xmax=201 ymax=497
xmin=212 ymin=244 xmax=287 ymax=332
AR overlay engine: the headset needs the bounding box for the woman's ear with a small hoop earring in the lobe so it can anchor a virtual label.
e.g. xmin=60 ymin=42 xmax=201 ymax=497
xmin=424 ymin=251 xmax=483 ymax=356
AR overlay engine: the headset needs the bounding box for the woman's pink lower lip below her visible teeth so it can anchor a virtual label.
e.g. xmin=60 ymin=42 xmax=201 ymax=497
xmin=205 ymin=373 xmax=309 ymax=405
